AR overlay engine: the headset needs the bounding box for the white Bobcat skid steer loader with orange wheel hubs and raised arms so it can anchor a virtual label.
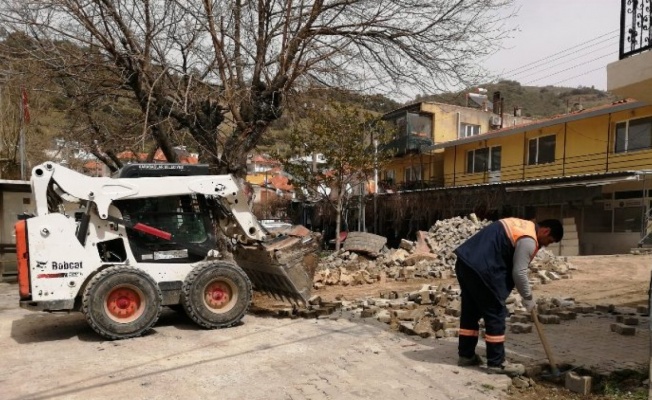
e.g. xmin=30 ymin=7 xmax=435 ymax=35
xmin=15 ymin=162 xmax=319 ymax=339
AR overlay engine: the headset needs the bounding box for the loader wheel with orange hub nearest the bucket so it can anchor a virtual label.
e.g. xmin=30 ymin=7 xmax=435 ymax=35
xmin=181 ymin=261 xmax=252 ymax=329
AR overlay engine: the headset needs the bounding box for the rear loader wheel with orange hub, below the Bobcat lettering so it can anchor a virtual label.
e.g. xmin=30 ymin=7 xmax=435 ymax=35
xmin=82 ymin=266 xmax=163 ymax=340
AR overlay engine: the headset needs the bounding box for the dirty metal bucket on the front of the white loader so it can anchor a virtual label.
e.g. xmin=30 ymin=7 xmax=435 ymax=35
xmin=233 ymin=226 xmax=320 ymax=304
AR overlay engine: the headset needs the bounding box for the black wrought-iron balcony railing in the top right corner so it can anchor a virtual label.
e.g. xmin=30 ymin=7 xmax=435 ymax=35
xmin=619 ymin=0 xmax=652 ymax=60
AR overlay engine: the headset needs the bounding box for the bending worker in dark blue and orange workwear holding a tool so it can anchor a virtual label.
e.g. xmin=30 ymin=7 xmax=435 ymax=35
xmin=455 ymin=218 xmax=564 ymax=377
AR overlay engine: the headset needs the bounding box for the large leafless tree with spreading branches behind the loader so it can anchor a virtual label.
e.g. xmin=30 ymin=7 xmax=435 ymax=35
xmin=0 ymin=0 xmax=512 ymax=176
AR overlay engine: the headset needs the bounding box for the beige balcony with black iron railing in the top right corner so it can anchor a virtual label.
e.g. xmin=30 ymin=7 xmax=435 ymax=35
xmin=607 ymin=0 xmax=652 ymax=103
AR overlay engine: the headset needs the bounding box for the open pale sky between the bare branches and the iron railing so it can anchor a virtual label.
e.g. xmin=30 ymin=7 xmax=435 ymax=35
xmin=484 ymin=0 xmax=620 ymax=90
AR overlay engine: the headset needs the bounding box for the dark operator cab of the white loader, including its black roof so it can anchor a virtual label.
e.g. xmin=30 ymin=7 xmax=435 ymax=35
xmin=114 ymin=164 xmax=216 ymax=263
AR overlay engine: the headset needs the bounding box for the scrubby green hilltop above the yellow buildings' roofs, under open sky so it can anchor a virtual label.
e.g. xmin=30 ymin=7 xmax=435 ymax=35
xmin=415 ymin=80 xmax=618 ymax=118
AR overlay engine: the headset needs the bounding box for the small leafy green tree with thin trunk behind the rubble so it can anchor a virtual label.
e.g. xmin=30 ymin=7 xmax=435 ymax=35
xmin=274 ymin=103 xmax=390 ymax=250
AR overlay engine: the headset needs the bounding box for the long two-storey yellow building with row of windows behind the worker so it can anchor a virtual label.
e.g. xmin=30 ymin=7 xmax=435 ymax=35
xmin=429 ymin=100 xmax=652 ymax=254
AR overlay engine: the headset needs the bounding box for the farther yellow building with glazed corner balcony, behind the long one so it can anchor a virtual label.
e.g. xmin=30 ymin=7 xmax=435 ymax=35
xmin=379 ymin=99 xmax=525 ymax=191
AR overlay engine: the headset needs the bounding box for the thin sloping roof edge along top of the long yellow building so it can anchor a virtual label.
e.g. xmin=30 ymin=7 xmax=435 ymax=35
xmin=423 ymin=99 xmax=649 ymax=150
